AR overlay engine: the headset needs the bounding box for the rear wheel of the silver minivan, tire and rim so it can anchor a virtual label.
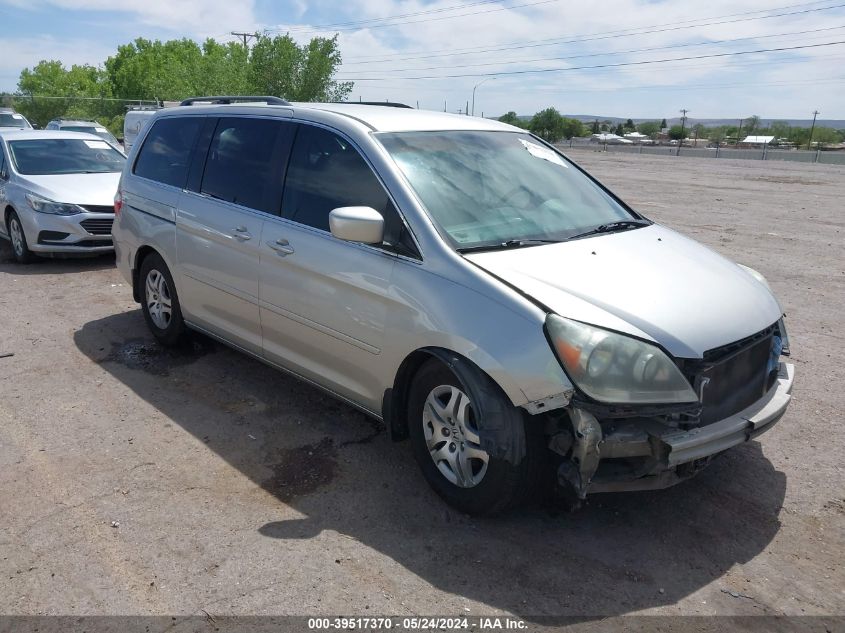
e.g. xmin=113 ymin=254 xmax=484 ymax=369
xmin=138 ymin=253 xmax=186 ymax=347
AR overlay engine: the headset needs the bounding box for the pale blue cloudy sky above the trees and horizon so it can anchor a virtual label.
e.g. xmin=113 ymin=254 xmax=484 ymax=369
xmin=0 ymin=0 xmax=845 ymax=119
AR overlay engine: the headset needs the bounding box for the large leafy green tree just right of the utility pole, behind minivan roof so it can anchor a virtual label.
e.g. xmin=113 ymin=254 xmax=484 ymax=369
xmin=248 ymin=35 xmax=352 ymax=101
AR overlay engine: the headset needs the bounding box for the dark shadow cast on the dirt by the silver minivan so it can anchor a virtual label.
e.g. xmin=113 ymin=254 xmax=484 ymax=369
xmin=75 ymin=311 xmax=786 ymax=619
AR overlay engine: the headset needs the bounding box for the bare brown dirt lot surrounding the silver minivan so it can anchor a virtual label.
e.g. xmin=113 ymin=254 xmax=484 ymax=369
xmin=0 ymin=150 xmax=845 ymax=622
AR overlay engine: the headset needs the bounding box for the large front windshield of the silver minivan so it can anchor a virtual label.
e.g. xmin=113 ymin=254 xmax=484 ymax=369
xmin=378 ymin=131 xmax=636 ymax=250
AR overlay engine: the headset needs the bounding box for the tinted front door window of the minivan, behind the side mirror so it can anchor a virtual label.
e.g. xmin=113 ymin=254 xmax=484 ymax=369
xmin=282 ymin=125 xmax=396 ymax=231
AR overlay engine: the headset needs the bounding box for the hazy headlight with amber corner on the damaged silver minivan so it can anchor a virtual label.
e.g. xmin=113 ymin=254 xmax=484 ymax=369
xmin=546 ymin=314 xmax=698 ymax=404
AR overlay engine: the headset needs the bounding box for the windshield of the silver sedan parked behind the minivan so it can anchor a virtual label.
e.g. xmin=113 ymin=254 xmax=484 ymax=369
xmin=9 ymin=138 xmax=126 ymax=176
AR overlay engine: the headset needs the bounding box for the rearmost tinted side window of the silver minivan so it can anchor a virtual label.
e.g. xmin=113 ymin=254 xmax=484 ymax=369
xmin=132 ymin=116 xmax=203 ymax=187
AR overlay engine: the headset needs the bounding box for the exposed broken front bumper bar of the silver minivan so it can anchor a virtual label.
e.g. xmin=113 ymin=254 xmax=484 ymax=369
xmin=558 ymin=363 xmax=795 ymax=499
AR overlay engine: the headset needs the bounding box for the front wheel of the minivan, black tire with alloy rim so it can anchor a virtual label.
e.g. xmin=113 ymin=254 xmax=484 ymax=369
xmin=408 ymin=359 xmax=543 ymax=515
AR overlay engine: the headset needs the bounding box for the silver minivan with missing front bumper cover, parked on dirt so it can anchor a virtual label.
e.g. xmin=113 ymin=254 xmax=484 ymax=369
xmin=114 ymin=98 xmax=794 ymax=514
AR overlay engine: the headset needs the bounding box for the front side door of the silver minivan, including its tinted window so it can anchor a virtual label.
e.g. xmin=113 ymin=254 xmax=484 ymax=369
xmin=259 ymin=124 xmax=412 ymax=411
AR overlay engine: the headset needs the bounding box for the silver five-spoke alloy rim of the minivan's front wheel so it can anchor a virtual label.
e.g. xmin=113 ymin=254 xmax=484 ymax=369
xmin=422 ymin=385 xmax=489 ymax=488
